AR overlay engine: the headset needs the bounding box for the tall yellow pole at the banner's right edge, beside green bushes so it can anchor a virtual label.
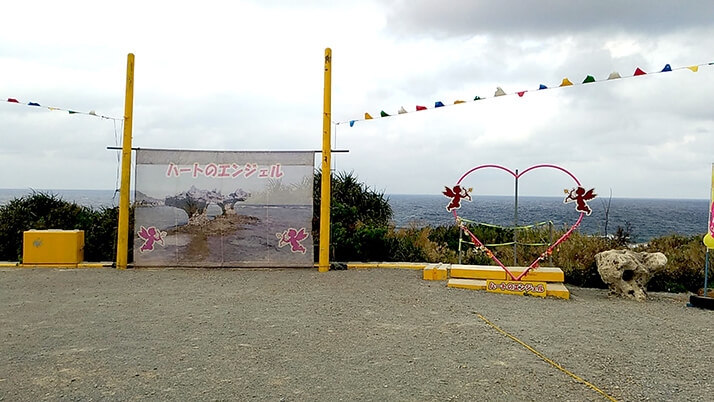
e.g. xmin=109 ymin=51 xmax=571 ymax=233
xmin=318 ymin=47 xmax=332 ymax=272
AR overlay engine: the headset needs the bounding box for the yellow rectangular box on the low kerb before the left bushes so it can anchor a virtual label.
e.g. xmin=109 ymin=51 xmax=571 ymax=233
xmin=22 ymin=229 xmax=84 ymax=266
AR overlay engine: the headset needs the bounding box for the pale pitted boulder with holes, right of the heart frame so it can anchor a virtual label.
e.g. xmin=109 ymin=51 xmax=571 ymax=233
xmin=595 ymin=250 xmax=667 ymax=301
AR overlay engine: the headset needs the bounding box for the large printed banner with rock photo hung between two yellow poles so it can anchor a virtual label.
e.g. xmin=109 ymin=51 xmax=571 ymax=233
xmin=134 ymin=149 xmax=315 ymax=267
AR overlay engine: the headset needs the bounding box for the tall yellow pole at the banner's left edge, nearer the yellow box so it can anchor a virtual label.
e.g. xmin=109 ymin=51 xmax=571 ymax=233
xmin=117 ymin=53 xmax=134 ymax=269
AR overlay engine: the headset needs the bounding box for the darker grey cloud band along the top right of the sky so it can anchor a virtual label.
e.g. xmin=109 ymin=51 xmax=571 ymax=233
xmin=387 ymin=0 xmax=714 ymax=38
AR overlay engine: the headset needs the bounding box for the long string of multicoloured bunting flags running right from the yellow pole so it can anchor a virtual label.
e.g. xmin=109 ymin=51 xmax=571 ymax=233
xmin=342 ymin=62 xmax=714 ymax=127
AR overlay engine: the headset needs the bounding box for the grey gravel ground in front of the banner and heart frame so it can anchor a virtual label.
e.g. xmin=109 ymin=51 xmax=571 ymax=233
xmin=0 ymin=268 xmax=714 ymax=401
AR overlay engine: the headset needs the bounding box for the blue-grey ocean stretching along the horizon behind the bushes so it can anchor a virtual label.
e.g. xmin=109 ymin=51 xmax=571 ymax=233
xmin=0 ymin=189 xmax=709 ymax=242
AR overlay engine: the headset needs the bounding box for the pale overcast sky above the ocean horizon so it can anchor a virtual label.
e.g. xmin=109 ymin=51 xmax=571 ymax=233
xmin=0 ymin=0 xmax=714 ymax=199
